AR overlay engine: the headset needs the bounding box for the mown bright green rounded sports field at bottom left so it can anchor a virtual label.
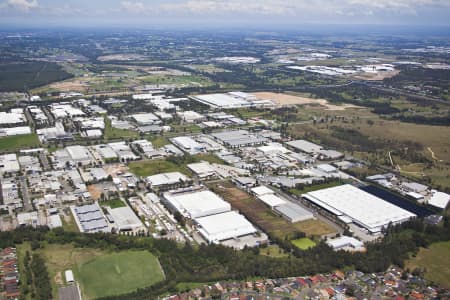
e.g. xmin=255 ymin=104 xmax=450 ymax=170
xmin=75 ymin=251 xmax=164 ymax=299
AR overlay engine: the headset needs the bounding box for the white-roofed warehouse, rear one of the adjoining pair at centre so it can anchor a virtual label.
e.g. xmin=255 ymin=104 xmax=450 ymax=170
xmin=163 ymin=188 xmax=231 ymax=219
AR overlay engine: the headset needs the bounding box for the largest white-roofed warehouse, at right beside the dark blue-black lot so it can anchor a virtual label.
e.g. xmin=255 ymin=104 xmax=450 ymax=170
xmin=302 ymin=184 xmax=416 ymax=233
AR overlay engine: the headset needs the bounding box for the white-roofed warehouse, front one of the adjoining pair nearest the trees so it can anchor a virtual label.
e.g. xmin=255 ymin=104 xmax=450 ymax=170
xmin=195 ymin=211 xmax=257 ymax=243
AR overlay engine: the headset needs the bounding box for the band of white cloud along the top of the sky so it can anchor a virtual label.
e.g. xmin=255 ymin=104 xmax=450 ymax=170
xmin=121 ymin=0 xmax=450 ymax=17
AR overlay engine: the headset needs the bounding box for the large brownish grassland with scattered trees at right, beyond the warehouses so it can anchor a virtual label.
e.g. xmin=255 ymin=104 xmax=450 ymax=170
xmin=289 ymin=110 xmax=450 ymax=188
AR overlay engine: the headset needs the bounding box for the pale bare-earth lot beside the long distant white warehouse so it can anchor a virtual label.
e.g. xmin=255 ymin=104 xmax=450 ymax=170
xmin=254 ymin=92 xmax=358 ymax=110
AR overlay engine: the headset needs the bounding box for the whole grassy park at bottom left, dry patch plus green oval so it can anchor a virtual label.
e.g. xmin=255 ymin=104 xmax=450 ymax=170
xmin=18 ymin=243 xmax=164 ymax=299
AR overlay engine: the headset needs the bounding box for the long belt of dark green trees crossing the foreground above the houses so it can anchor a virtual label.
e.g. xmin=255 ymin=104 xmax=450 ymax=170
xmin=0 ymin=218 xmax=450 ymax=299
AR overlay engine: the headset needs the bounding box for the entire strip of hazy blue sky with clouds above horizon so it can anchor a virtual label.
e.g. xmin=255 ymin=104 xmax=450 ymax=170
xmin=0 ymin=0 xmax=450 ymax=27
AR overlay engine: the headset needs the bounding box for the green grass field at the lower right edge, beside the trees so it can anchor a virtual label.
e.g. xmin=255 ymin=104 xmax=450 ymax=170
xmin=406 ymin=241 xmax=450 ymax=288
